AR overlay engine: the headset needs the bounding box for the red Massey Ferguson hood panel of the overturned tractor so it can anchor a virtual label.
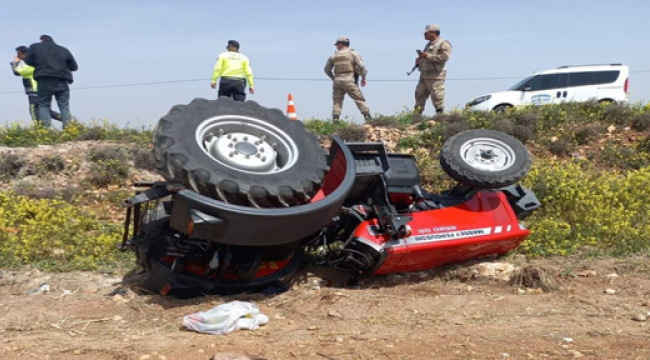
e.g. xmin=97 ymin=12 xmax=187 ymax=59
xmin=353 ymin=191 xmax=530 ymax=274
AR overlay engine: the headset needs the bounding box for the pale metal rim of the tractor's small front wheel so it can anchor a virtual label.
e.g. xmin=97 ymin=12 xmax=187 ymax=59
xmin=460 ymin=138 xmax=517 ymax=172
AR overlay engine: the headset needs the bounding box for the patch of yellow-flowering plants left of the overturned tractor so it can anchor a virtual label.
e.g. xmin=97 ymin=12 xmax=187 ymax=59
xmin=0 ymin=192 xmax=124 ymax=270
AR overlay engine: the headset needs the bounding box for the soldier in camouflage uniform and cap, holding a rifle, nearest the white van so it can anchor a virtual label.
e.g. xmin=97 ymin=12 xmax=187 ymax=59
xmin=415 ymin=25 xmax=452 ymax=114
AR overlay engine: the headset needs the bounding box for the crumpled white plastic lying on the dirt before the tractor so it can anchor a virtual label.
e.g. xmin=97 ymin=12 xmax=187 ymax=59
xmin=183 ymin=301 xmax=269 ymax=335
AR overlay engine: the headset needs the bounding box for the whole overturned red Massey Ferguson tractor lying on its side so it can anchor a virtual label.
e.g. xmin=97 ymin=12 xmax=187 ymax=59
xmin=122 ymin=99 xmax=540 ymax=297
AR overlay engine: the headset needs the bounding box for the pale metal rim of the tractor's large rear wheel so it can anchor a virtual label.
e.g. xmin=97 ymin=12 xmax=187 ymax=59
xmin=196 ymin=115 xmax=299 ymax=174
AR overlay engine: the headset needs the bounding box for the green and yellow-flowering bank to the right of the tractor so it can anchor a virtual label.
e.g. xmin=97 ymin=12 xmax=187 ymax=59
xmin=308 ymin=103 xmax=650 ymax=256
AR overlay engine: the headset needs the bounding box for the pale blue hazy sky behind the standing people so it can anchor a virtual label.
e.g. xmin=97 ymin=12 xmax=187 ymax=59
xmin=0 ymin=0 xmax=650 ymax=126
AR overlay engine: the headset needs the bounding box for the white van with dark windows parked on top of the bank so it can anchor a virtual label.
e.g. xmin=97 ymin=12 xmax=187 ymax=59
xmin=467 ymin=64 xmax=630 ymax=111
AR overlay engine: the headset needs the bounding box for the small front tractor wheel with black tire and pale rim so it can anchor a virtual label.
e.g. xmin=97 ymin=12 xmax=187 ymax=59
xmin=440 ymin=130 xmax=532 ymax=189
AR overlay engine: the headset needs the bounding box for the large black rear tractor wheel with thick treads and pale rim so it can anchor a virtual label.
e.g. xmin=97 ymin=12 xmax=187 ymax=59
xmin=154 ymin=98 xmax=328 ymax=207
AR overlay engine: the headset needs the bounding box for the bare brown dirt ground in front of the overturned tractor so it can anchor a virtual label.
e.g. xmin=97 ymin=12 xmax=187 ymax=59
xmin=0 ymin=257 xmax=650 ymax=360
